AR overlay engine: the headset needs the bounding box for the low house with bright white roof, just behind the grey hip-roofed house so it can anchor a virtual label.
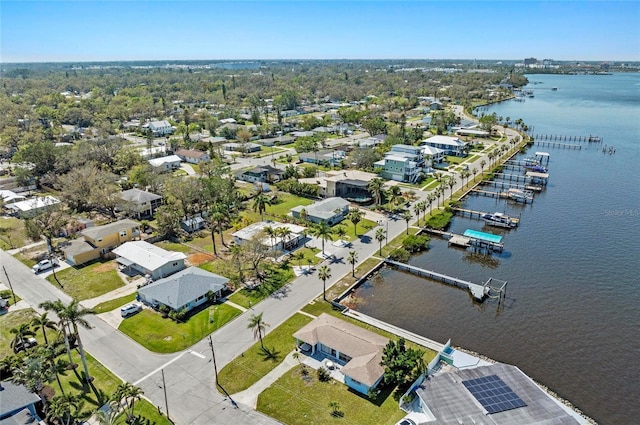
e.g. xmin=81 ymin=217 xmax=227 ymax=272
xmin=113 ymin=241 xmax=187 ymax=280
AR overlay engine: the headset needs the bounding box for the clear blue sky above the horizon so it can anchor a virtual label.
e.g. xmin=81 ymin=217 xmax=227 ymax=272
xmin=0 ymin=0 xmax=640 ymax=62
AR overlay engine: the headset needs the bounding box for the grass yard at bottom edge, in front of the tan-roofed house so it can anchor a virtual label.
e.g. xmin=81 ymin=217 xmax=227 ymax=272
xmin=257 ymin=366 xmax=405 ymax=425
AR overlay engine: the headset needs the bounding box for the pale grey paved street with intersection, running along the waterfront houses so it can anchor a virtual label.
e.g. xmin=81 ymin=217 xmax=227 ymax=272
xmin=0 ymin=120 xmax=520 ymax=425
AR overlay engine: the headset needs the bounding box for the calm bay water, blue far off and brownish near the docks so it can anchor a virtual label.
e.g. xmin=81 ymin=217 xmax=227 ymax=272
xmin=357 ymin=74 xmax=640 ymax=424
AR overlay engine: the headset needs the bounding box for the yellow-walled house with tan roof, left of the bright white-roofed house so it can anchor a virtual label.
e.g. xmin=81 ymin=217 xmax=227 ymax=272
xmin=62 ymin=219 xmax=140 ymax=266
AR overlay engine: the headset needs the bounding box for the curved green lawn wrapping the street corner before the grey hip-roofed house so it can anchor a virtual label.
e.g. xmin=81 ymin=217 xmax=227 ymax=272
xmin=118 ymin=304 xmax=241 ymax=353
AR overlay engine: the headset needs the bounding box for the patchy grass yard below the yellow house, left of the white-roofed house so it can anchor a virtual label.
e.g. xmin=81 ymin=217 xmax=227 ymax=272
xmin=47 ymin=260 xmax=124 ymax=300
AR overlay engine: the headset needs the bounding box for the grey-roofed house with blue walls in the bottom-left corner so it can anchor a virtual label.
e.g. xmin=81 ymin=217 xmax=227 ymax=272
xmin=0 ymin=381 xmax=41 ymax=425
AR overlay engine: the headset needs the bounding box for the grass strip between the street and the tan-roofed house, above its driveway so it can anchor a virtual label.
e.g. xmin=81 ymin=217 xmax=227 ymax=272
xmin=218 ymin=313 xmax=312 ymax=394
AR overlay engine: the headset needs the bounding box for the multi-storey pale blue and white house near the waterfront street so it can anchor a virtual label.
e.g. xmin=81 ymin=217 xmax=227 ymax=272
xmin=374 ymin=145 xmax=424 ymax=183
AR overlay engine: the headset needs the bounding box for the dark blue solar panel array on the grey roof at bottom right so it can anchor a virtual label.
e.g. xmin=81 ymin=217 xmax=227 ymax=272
xmin=462 ymin=375 xmax=527 ymax=414
